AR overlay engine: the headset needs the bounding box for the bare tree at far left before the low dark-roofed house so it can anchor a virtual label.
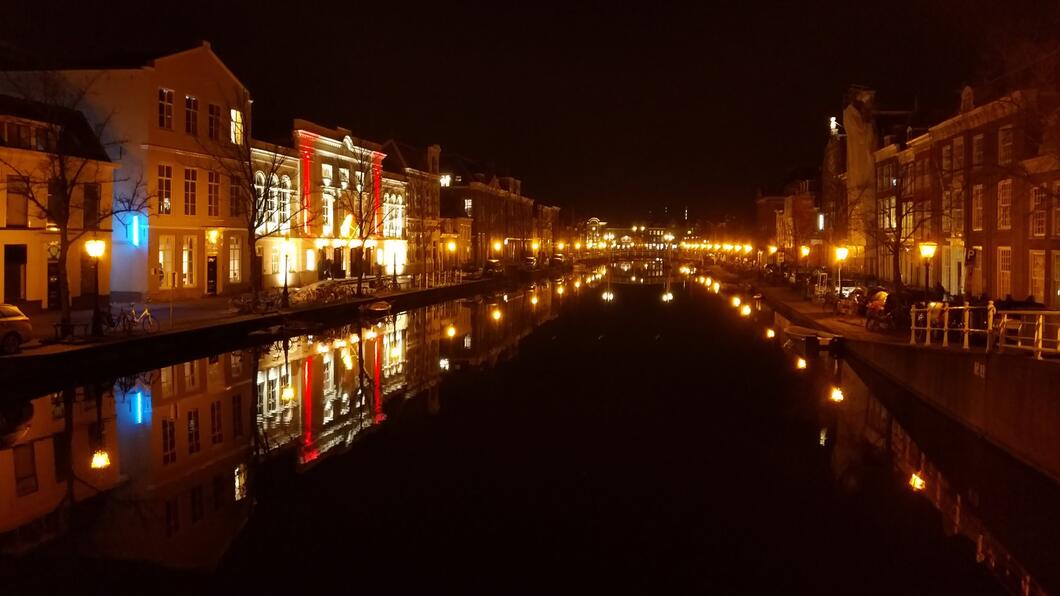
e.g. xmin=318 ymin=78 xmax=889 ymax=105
xmin=0 ymin=72 xmax=148 ymax=334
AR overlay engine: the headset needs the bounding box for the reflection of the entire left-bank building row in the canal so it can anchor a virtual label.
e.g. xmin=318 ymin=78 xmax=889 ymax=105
xmin=0 ymin=277 xmax=572 ymax=567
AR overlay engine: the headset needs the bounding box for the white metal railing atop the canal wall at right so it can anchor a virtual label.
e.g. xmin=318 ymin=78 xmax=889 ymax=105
xmin=909 ymin=300 xmax=1060 ymax=360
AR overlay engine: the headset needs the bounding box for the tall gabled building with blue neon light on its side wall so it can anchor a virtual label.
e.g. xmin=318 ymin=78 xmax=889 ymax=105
xmin=6 ymin=42 xmax=258 ymax=300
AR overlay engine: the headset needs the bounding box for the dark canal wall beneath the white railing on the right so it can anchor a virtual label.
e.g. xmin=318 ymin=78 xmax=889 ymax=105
xmin=771 ymin=288 xmax=1060 ymax=481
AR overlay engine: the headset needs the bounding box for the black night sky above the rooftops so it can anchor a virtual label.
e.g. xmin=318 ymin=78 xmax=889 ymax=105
xmin=0 ymin=0 xmax=1060 ymax=218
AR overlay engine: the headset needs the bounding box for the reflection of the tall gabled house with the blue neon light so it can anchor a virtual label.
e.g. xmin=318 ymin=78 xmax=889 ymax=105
xmin=86 ymin=351 xmax=253 ymax=566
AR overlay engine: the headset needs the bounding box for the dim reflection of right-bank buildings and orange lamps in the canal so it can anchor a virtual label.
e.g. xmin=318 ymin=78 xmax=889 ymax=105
xmin=818 ymin=354 xmax=1046 ymax=595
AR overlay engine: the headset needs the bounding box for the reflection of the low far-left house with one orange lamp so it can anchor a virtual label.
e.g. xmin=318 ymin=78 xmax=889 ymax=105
xmin=0 ymin=389 xmax=121 ymax=553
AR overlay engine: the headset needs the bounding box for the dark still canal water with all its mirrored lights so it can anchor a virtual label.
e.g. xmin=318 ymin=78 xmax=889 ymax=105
xmin=0 ymin=269 xmax=1060 ymax=594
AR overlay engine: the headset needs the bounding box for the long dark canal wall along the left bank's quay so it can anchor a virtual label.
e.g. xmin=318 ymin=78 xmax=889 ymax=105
xmin=0 ymin=270 xmax=552 ymax=403
